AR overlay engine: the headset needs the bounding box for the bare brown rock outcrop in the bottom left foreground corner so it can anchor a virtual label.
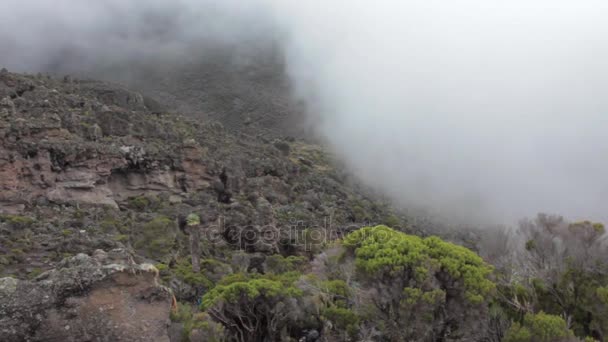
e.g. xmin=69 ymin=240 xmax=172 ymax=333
xmin=0 ymin=249 xmax=172 ymax=342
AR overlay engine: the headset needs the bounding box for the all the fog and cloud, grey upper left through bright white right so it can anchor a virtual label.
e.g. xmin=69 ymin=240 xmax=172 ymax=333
xmin=0 ymin=0 xmax=608 ymax=221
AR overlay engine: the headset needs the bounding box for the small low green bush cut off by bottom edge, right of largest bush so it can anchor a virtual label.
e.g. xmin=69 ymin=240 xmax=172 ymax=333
xmin=503 ymin=312 xmax=574 ymax=342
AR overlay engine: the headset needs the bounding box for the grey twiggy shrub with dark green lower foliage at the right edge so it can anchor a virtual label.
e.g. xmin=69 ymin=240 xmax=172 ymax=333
xmin=516 ymin=215 xmax=608 ymax=340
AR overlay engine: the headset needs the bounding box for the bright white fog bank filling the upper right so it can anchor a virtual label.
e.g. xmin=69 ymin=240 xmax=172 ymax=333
xmin=270 ymin=0 xmax=608 ymax=220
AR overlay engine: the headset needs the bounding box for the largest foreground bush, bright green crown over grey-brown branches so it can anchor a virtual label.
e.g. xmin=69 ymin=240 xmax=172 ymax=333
xmin=343 ymin=226 xmax=495 ymax=341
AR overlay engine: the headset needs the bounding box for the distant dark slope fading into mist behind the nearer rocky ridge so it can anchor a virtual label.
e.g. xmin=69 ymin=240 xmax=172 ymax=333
xmin=44 ymin=43 xmax=311 ymax=138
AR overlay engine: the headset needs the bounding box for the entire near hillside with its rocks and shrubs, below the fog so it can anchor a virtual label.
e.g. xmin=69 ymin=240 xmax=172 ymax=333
xmin=0 ymin=69 xmax=608 ymax=342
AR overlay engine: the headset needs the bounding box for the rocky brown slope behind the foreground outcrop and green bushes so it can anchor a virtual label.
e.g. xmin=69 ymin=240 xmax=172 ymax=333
xmin=0 ymin=70 xmax=400 ymax=338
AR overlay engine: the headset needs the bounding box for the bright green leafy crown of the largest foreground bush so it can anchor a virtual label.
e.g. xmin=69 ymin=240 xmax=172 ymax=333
xmin=343 ymin=226 xmax=495 ymax=303
